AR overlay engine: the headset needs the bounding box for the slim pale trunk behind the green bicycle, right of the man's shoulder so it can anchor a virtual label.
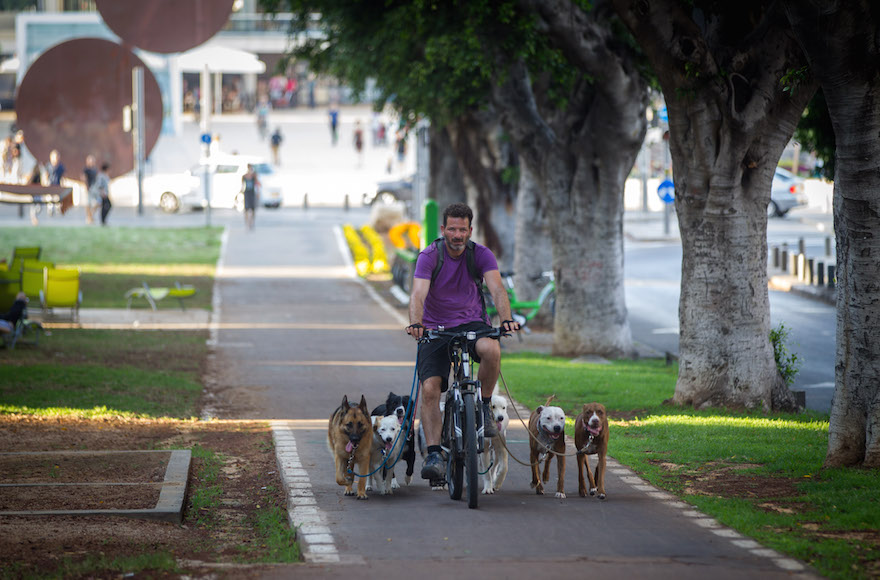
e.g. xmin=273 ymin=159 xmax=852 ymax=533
xmin=513 ymin=164 xmax=553 ymax=329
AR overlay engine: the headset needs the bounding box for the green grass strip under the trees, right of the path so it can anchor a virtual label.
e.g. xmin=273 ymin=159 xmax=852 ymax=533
xmin=502 ymin=353 xmax=880 ymax=579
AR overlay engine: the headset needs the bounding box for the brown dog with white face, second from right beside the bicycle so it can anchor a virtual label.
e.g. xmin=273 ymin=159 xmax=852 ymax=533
xmin=529 ymin=395 xmax=565 ymax=498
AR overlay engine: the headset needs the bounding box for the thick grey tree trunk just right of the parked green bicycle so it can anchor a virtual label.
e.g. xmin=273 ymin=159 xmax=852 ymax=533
xmin=492 ymin=0 xmax=648 ymax=358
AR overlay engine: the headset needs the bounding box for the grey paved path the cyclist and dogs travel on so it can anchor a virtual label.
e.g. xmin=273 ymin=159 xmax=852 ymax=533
xmin=211 ymin=212 xmax=815 ymax=579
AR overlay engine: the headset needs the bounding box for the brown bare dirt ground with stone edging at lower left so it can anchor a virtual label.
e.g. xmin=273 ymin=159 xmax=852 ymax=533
xmin=0 ymin=416 xmax=296 ymax=578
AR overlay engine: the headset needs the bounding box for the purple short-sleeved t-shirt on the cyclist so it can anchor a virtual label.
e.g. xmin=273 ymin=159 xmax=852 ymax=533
xmin=414 ymin=244 xmax=498 ymax=328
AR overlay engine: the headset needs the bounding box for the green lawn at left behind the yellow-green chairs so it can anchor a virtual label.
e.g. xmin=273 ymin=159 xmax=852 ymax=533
xmin=0 ymin=226 xmax=223 ymax=309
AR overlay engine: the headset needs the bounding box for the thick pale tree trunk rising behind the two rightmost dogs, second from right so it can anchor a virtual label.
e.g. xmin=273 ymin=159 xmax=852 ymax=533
xmin=614 ymin=0 xmax=815 ymax=410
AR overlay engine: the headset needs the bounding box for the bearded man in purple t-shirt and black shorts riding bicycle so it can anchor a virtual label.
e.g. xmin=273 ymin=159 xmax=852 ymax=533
xmin=406 ymin=203 xmax=519 ymax=480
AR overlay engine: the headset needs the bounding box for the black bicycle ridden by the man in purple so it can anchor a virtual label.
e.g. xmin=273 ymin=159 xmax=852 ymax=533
xmin=421 ymin=326 xmax=509 ymax=509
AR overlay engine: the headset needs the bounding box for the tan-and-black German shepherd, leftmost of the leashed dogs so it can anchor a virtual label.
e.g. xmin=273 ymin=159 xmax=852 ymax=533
xmin=327 ymin=395 xmax=373 ymax=499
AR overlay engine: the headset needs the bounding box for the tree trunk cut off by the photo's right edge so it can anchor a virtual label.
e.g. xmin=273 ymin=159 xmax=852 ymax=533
xmin=786 ymin=0 xmax=880 ymax=468
